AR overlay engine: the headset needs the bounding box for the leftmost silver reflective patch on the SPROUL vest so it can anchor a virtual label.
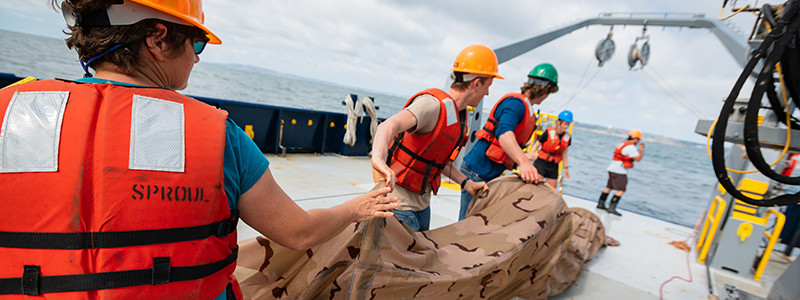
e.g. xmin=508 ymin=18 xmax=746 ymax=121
xmin=0 ymin=91 xmax=69 ymax=173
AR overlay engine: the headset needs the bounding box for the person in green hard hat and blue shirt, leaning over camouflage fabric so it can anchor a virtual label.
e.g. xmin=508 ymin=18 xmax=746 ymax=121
xmin=458 ymin=63 xmax=558 ymax=220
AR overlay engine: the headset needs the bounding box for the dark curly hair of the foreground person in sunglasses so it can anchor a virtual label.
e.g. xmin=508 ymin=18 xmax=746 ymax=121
xmin=51 ymin=0 xmax=200 ymax=74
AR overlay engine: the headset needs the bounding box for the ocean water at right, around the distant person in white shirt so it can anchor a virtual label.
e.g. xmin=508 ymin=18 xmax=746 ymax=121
xmin=564 ymin=124 xmax=717 ymax=226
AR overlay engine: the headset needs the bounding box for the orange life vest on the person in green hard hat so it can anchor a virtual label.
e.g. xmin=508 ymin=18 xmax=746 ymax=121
xmin=475 ymin=93 xmax=536 ymax=170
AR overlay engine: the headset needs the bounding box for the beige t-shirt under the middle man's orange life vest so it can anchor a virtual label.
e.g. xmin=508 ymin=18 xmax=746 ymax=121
xmin=389 ymin=94 xmax=440 ymax=211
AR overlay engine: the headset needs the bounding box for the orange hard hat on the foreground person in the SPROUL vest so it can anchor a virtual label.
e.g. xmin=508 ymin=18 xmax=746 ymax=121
xmin=130 ymin=0 xmax=222 ymax=44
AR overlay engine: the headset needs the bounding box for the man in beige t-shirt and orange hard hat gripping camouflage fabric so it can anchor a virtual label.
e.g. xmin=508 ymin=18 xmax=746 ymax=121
xmin=372 ymin=45 xmax=503 ymax=231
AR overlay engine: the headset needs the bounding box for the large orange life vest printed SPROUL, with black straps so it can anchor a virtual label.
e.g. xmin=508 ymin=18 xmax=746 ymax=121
xmin=0 ymin=79 xmax=240 ymax=299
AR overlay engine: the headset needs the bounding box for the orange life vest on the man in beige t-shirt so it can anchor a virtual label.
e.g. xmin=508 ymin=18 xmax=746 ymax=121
xmin=386 ymin=89 xmax=467 ymax=195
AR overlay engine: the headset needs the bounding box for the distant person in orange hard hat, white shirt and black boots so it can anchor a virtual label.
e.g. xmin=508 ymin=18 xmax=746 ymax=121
xmin=597 ymin=129 xmax=644 ymax=216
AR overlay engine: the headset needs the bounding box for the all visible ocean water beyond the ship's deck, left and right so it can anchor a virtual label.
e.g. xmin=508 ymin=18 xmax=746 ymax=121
xmin=0 ymin=30 xmax=716 ymax=226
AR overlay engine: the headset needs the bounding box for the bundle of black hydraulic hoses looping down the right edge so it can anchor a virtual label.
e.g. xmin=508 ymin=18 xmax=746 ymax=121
xmin=711 ymin=0 xmax=800 ymax=206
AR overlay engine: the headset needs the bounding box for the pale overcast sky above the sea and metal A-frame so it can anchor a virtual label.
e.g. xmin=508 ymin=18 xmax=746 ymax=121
xmin=0 ymin=0 xmax=781 ymax=142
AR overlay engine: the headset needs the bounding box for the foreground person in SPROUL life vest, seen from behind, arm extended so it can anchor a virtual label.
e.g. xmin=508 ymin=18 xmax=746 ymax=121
xmin=0 ymin=0 xmax=397 ymax=299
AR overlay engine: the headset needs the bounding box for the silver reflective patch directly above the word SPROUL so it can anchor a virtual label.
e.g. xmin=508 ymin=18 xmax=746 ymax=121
xmin=128 ymin=95 xmax=186 ymax=172
